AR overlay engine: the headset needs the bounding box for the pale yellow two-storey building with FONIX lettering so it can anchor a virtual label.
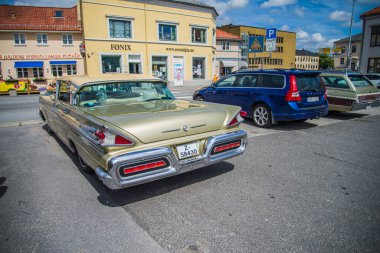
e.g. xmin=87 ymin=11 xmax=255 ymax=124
xmin=79 ymin=0 xmax=218 ymax=85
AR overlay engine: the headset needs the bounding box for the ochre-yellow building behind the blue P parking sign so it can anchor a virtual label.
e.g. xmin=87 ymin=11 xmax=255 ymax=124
xmin=218 ymin=25 xmax=296 ymax=69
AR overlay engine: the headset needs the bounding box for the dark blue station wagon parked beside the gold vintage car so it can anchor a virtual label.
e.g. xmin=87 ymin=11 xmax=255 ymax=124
xmin=193 ymin=70 xmax=328 ymax=128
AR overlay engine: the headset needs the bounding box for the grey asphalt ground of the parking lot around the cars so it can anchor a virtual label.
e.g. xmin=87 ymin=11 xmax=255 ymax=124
xmin=0 ymin=93 xmax=380 ymax=252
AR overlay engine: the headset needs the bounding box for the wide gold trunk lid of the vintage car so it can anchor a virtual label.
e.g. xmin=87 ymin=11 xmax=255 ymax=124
xmin=81 ymin=100 xmax=226 ymax=143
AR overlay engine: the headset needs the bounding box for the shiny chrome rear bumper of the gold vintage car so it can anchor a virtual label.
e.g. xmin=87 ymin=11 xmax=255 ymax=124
xmin=95 ymin=130 xmax=247 ymax=189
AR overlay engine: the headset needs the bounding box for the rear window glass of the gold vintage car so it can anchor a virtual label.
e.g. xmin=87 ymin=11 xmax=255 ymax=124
xmin=76 ymin=82 xmax=175 ymax=107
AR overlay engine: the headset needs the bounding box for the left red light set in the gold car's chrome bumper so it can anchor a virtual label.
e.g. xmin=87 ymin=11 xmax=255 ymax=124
xmin=120 ymin=158 xmax=170 ymax=177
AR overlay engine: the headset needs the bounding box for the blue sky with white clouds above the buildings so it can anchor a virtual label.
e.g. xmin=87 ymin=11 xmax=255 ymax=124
xmin=0 ymin=0 xmax=380 ymax=52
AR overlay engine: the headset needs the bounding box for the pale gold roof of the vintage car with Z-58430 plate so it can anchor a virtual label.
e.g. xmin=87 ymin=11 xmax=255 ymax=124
xmin=57 ymin=74 xmax=166 ymax=86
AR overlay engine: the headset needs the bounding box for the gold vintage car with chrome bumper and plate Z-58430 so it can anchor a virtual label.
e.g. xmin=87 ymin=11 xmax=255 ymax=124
xmin=40 ymin=75 xmax=247 ymax=189
